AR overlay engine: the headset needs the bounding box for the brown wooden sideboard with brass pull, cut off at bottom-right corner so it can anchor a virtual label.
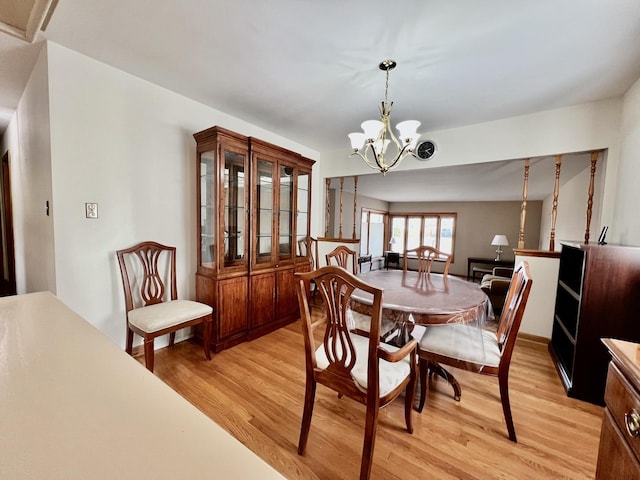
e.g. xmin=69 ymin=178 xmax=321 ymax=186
xmin=596 ymin=339 xmax=640 ymax=480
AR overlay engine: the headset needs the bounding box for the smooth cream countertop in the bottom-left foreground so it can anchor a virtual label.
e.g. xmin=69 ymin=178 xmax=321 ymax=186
xmin=0 ymin=292 xmax=284 ymax=480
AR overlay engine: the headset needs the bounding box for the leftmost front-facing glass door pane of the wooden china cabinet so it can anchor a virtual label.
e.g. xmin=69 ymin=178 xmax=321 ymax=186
xmin=220 ymin=148 xmax=247 ymax=268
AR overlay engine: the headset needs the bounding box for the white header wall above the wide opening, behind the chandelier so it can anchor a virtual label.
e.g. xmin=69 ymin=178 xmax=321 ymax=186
xmin=314 ymin=100 xmax=624 ymax=240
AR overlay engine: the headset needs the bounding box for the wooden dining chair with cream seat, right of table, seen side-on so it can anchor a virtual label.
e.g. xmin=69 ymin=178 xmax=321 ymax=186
xmin=418 ymin=262 xmax=533 ymax=442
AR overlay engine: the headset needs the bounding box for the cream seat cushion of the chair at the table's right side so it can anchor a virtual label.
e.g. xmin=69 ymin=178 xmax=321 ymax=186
xmin=418 ymin=323 xmax=501 ymax=367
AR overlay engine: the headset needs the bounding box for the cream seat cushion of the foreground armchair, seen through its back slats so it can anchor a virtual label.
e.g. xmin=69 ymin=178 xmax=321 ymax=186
xmin=316 ymin=334 xmax=411 ymax=397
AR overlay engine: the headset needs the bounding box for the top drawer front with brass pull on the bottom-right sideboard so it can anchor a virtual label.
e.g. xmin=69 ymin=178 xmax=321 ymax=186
xmin=604 ymin=362 xmax=640 ymax=459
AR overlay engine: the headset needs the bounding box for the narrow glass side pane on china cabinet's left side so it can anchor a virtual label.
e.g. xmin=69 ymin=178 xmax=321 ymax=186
xmin=200 ymin=151 xmax=216 ymax=269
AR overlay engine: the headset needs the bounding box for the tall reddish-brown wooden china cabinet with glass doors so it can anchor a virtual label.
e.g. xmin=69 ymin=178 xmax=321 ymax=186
xmin=194 ymin=127 xmax=314 ymax=352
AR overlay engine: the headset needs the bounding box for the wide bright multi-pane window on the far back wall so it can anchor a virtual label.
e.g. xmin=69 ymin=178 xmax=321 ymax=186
xmin=390 ymin=213 xmax=456 ymax=255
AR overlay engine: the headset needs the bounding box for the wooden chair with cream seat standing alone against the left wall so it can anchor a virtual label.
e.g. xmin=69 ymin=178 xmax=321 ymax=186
xmin=116 ymin=242 xmax=213 ymax=372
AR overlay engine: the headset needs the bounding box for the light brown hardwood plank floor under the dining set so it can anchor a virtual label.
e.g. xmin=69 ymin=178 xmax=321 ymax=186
xmin=146 ymin=316 xmax=603 ymax=480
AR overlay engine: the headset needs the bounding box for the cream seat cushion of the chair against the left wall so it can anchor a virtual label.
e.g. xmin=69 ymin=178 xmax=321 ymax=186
xmin=127 ymin=300 xmax=213 ymax=333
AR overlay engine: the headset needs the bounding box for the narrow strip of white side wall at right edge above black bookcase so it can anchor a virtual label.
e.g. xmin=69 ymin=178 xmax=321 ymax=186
xmin=607 ymin=79 xmax=640 ymax=246
